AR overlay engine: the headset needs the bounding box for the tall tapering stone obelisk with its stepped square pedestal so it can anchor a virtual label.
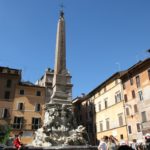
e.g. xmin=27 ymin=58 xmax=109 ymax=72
xmin=50 ymin=10 xmax=72 ymax=104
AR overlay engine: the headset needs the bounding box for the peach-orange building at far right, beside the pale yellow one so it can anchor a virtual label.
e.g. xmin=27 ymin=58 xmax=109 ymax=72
xmin=122 ymin=59 xmax=150 ymax=141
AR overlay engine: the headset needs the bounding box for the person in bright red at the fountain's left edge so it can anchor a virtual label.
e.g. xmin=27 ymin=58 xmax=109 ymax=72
xmin=13 ymin=131 xmax=23 ymax=150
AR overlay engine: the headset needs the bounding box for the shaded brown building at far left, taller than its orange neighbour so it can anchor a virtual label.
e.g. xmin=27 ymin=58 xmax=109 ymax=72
xmin=0 ymin=67 xmax=21 ymax=124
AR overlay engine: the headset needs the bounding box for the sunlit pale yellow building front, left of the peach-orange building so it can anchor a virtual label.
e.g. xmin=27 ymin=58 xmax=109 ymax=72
xmin=94 ymin=72 xmax=128 ymax=141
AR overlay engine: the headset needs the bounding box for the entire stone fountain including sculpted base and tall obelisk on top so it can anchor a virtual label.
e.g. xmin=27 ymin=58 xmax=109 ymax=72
xmin=29 ymin=11 xmax=96 ymax=150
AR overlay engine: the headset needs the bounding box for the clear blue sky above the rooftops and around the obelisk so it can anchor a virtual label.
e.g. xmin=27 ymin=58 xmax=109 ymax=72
xmin=0 ymin=0 xmax=150 ymax=97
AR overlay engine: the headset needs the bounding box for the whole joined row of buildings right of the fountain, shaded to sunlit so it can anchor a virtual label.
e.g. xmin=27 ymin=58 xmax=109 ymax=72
xmin=73 ymin=58 xmax=150 ymax=145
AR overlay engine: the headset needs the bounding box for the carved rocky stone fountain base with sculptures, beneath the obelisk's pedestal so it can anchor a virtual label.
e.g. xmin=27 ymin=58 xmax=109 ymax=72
xmin=33 ymin=104 xmax=87 ymax=147
